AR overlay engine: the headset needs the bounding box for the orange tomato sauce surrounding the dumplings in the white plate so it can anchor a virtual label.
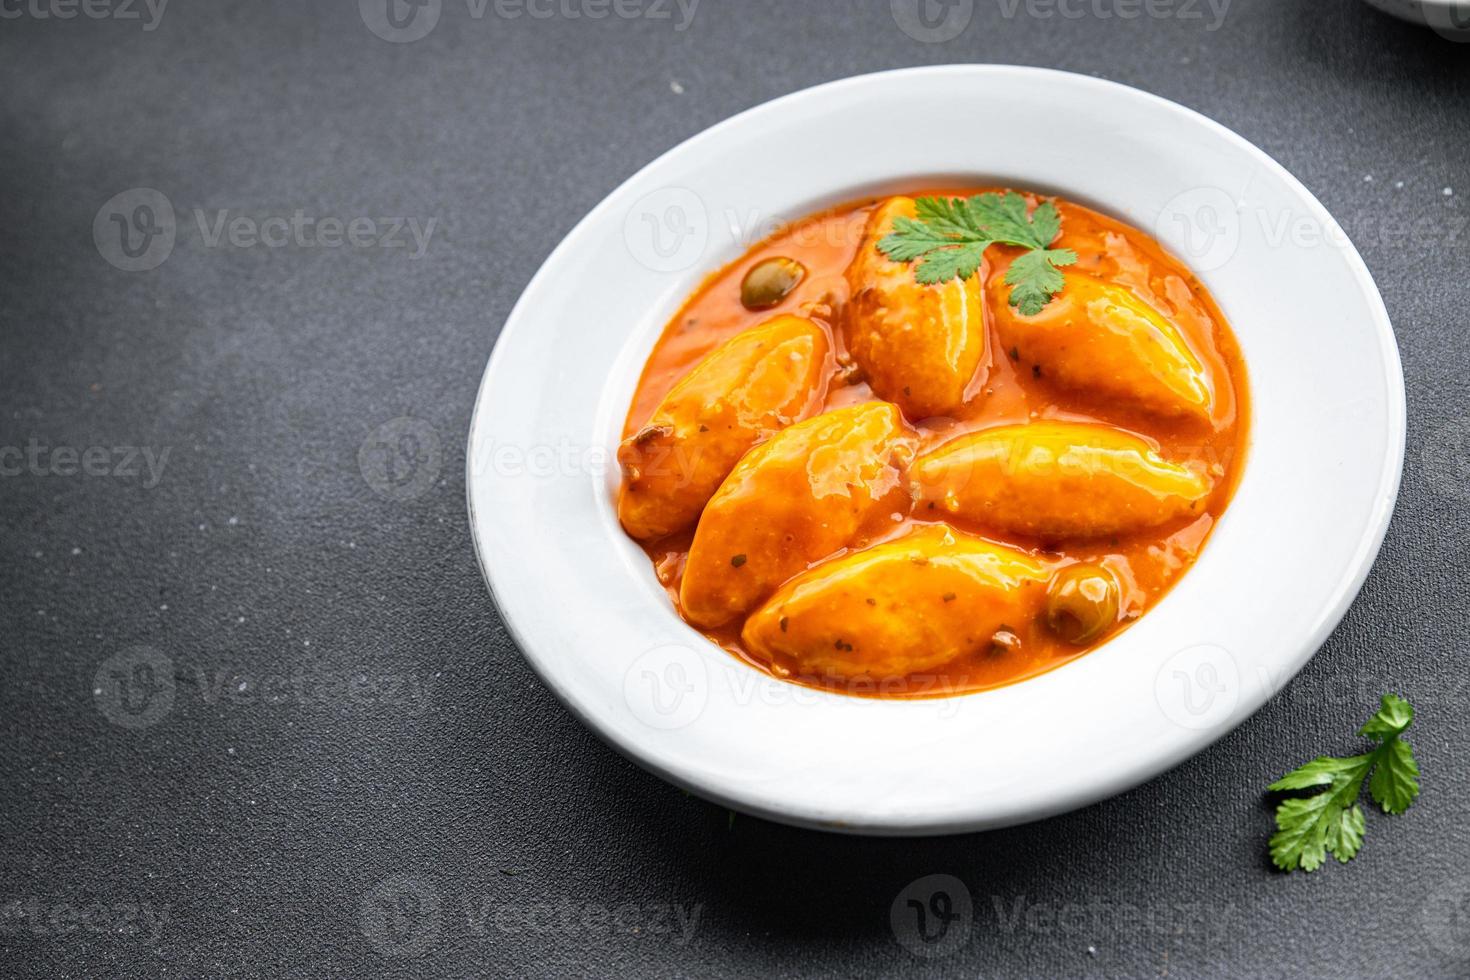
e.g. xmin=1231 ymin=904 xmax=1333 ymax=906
xmin=623 ymin=187 xmax=1250 ymax=698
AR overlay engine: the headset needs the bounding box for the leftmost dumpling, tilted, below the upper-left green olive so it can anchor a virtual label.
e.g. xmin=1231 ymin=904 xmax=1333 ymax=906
xmin=617 ymin=316 xmax=829 ymax=541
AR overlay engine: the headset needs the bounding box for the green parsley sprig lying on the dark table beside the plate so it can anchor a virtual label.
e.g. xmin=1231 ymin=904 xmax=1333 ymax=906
xmin=1270 ymin=693 xmax=1419 ymax=871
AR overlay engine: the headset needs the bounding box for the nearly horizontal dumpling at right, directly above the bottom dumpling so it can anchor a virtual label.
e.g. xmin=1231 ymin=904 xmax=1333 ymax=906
xmin=910 ymin=422 xmax=1214 ymax=539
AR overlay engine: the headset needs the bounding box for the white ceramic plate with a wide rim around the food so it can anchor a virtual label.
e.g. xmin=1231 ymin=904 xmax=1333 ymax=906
xmin=467 ymin=66 xmax=1404 ymax=835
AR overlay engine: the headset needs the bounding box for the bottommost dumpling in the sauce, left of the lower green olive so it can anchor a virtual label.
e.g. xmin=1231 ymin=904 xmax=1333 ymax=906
xmin=741 ymin=525 xmax=1050 ymax=679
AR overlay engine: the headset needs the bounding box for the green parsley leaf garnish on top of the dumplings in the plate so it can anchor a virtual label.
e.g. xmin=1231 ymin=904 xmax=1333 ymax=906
xmin=878 ymin=191 xmax=1078 ymax=316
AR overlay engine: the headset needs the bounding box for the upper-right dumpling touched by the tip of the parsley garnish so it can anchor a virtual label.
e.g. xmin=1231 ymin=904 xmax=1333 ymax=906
xmin=989 ymin=272 xmax=1216 ymax=422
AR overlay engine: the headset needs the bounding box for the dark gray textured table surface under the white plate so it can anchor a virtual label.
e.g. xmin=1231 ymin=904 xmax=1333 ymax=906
xmin=0 ymin=0 xmax=1470 ymax=977
